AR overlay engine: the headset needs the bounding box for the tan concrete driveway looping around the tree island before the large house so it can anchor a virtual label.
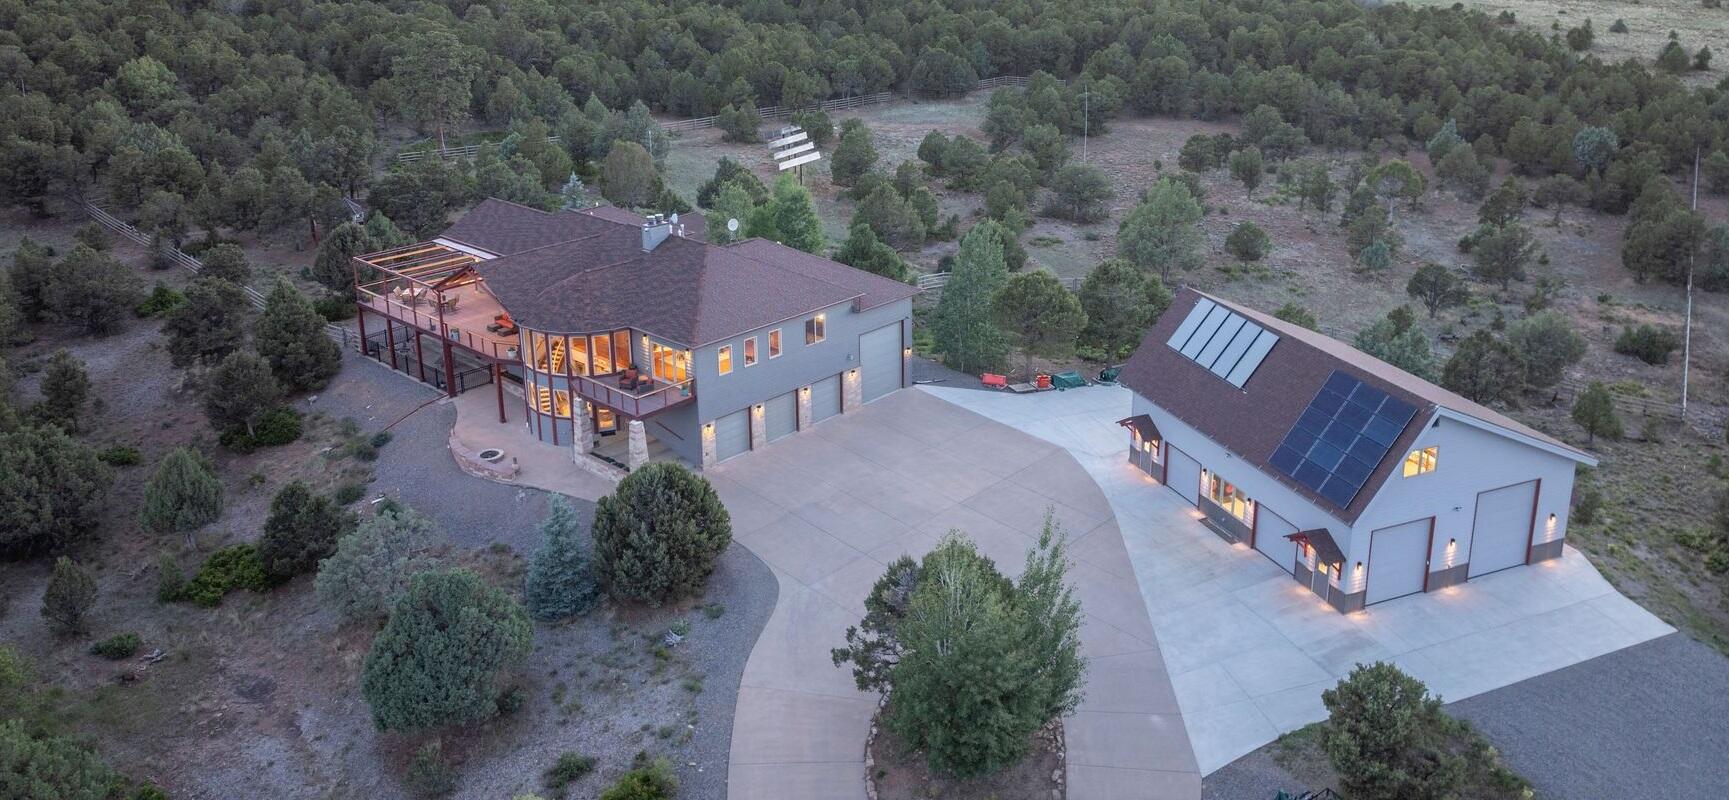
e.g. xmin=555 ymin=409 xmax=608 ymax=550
xmin=707 ymin=390 xmax=1200 ymax=800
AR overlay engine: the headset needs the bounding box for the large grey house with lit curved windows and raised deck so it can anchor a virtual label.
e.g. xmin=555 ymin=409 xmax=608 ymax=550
xmin=353 ymin=199 xmax=916 ymax=468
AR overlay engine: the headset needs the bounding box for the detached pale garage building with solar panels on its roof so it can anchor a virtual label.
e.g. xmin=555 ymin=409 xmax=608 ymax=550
xmin=1120 ymin=289 xmax=1596 ymax=612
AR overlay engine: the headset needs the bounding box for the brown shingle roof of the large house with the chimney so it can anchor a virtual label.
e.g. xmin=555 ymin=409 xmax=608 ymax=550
xmin=443 ymin=200 xmax=916 ymax=347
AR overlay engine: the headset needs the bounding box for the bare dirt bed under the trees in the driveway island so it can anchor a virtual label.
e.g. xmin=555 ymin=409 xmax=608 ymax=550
xmin=865 ymin=714 xmax=1067 ymax=800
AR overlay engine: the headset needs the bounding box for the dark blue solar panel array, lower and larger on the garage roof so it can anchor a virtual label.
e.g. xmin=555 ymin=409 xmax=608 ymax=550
xmin=1271 ymin=370 xmax=1416 ymax=508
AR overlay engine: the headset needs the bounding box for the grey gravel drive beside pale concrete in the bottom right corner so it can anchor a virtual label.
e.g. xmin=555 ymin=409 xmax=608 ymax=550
xmin=1202 ymin=634 xmax=1729 ymax=800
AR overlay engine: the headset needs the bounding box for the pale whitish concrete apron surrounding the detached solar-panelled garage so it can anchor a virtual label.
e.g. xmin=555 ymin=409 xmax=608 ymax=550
xmin=918 ymin=387 xmax=1674 ymax=774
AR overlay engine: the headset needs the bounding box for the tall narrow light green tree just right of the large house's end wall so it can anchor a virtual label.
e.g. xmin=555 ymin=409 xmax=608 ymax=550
xmin=930 ymin=219 xmax=1008 ymax=371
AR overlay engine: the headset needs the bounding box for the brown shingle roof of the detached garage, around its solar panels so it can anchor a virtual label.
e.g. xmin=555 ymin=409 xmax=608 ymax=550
xmin=1120 ymin=289 xmax=1589 ymax=524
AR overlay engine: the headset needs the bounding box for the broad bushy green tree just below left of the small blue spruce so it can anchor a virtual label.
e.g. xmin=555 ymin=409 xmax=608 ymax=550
xmin=360 ymin=570 xmax=534 ymax=731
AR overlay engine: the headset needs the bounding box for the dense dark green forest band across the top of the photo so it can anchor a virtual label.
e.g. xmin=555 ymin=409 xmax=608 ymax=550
xmin=0 ymin=0 xmax=1729 ymax=238
